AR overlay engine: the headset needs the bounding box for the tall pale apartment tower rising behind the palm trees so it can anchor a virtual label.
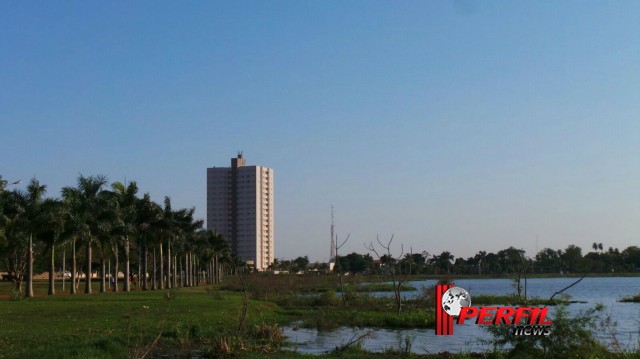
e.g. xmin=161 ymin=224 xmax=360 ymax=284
xmin=207 ymin=153 xmax=274 ymax=270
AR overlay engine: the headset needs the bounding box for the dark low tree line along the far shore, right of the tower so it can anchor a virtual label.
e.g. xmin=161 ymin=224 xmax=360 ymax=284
xmin=271 ymin=243 xmax=640 ymax=275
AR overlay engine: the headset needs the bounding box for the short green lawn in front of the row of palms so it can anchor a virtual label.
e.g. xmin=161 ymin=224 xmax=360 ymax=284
xmin=0 ymin=283 xmax=287 ymax=358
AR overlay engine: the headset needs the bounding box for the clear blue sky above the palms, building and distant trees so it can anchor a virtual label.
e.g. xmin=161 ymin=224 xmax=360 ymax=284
xmin=0 ymin=0 xmax=640 ymax=260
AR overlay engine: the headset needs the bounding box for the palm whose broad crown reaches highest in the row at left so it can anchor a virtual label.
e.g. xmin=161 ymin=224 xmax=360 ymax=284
xmin=62 ymin=175 xmax=112 ymax=294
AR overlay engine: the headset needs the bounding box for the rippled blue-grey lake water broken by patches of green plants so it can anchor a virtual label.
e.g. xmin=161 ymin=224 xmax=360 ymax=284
xmin=283 ymin=277 xmax=640 ymax=354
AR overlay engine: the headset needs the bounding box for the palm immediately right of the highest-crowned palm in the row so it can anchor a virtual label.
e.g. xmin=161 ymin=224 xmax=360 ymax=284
xmin=111 ymin=182 xmax=138 ymax=292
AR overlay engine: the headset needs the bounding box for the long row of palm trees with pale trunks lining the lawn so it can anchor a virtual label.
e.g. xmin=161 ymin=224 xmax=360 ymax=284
xmin=0 ymin=175 xmax=232 ymax=297
